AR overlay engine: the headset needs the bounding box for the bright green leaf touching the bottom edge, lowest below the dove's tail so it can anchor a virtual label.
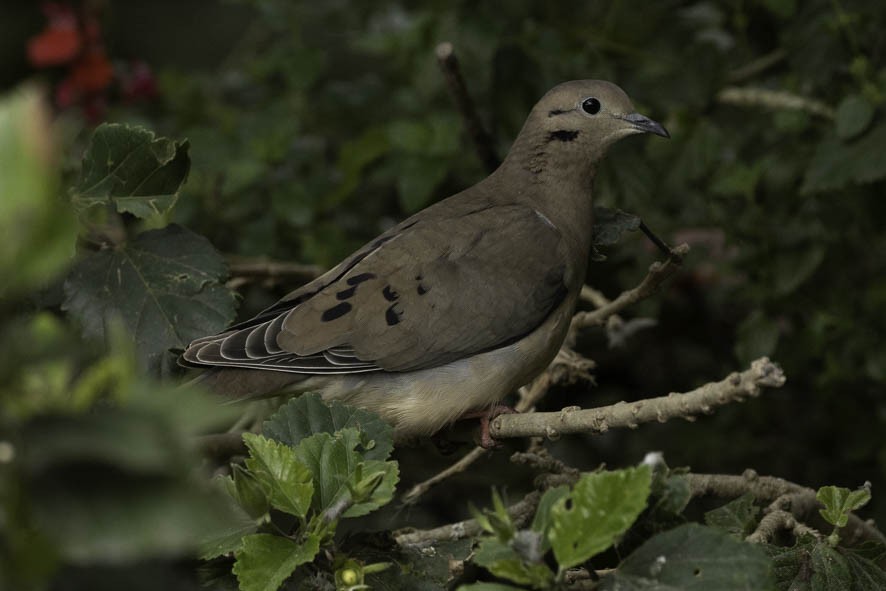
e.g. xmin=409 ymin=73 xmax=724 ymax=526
xmin=234 ymin=534 xmax=320 ymax=591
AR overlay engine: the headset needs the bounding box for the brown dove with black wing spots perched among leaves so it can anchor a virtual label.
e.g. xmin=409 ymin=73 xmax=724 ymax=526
xmin=182 ymin=80 xmax=669 ymax=439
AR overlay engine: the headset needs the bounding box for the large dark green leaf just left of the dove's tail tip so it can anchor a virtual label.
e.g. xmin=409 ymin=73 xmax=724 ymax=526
xmin=62 ymin=225 xmax=234 ymax=367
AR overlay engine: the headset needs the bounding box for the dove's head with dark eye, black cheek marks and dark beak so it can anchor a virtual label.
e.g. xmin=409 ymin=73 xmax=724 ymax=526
xmin=502 ymin=80 xmax=670 ymax=178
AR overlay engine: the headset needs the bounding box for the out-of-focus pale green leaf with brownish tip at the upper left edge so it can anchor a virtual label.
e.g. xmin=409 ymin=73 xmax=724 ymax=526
xmin=0 ymin=87 xmax=77 ymax=297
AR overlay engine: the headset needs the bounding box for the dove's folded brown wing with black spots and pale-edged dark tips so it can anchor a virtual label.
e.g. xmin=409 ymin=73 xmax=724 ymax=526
xmin=184 ymin=204 xmax=575 ymax=374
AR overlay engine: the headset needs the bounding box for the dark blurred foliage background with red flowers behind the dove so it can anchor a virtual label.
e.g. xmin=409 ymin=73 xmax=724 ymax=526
xmin=0 ymin=0 xmax=886 ymax=588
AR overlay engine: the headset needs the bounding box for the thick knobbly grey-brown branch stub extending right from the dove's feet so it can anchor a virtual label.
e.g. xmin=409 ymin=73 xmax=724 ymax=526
xmin=489 ymin=357 xmax=785 ymax=439
